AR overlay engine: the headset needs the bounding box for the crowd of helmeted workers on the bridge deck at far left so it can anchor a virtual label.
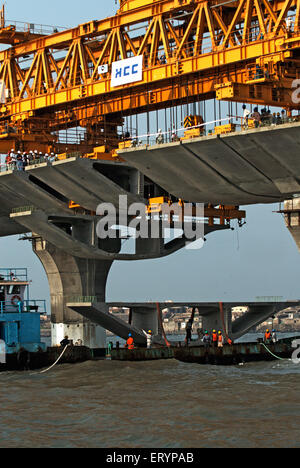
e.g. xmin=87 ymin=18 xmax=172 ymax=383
xmin=5 ymin=149 xmax=57 ymax=171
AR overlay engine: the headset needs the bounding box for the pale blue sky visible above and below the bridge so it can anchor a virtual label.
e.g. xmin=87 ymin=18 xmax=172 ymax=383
xmin=0 ymin=0 xmax=300 ymax=308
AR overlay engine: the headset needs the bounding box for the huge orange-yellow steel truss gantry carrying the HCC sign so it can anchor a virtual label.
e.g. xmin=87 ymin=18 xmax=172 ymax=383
xmin=0 ymin=0 xmax=300 ymax=157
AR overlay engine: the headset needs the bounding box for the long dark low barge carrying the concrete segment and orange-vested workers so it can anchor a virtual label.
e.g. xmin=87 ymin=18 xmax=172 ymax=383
xmin=109 ymin=336 xmax=300 ymax=366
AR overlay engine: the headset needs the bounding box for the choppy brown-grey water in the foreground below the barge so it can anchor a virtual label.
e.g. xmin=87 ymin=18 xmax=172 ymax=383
xmin=0 ymin=350 xmax=300 ymax=448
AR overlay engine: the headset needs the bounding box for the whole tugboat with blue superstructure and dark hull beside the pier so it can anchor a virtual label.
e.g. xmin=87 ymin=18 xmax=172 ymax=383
xmin=0 ymin=268 xmax=93 ymax=372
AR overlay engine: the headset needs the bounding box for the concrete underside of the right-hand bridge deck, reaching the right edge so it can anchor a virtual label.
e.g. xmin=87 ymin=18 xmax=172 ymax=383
xmin=119 ymin=123 xmax=300 ymax=205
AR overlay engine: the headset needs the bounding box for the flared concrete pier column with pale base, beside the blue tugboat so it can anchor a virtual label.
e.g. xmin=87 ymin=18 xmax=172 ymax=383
xmin=33 ymin=237 xmax=113 ymax=349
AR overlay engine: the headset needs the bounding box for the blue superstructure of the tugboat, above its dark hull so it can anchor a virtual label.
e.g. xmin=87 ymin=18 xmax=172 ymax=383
xmin=0 ymin=268 xmax=46 ymax=359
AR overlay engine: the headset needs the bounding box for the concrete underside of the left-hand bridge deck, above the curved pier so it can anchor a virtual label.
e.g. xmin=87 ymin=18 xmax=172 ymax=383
xmin=0 ymin=158 xmax=144 ymax=237
